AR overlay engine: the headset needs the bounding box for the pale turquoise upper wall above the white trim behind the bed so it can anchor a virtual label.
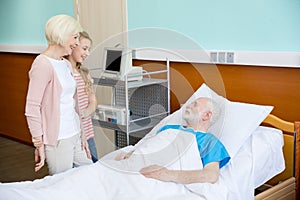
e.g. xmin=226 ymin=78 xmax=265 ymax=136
xmin=127 ymin=0 xmax=300 ymax=52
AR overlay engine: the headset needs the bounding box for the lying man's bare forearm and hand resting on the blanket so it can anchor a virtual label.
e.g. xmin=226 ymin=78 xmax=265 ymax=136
xmin=140 ymin=162 xmax=220 ymax=184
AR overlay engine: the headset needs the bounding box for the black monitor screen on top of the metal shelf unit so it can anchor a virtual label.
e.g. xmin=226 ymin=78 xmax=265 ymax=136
xmin=105 ymin=49 xmax=122 ymax=72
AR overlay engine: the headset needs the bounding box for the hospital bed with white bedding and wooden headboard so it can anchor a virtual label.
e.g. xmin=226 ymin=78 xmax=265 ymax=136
xmin=0 ymin=84 xmax=300 ymax=200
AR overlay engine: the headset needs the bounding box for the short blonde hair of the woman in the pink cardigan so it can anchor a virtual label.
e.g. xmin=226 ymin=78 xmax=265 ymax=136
xmin=45 ymin=15 xmax=82 ymax=45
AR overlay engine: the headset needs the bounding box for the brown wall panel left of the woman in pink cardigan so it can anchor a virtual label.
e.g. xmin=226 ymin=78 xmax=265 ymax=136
xmin=0 ymin=52 xmax=36 ymax=143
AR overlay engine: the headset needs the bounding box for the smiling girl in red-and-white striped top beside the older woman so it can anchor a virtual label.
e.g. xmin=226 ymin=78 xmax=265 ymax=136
xmin=67 ymin=31 xmax=98 ymax=162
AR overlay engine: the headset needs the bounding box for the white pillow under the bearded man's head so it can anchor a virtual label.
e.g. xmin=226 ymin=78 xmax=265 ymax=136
xmin=150 ymin=83 xmax=273 ymax=157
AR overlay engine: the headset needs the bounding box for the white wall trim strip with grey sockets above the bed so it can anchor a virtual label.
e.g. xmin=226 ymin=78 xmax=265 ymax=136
xmin=134 ymin=48 xmax=300 ymax=68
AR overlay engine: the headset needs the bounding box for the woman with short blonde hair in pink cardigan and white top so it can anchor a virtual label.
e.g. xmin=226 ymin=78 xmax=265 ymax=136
xmin=25 ymin=15 xmax=92 ymax=174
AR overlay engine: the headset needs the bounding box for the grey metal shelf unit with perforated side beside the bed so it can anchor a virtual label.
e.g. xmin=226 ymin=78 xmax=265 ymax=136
xmin=93 ymin=59 xmax=170 ymax=148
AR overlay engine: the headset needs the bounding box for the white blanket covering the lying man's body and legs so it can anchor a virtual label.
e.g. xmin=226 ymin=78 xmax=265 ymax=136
xmin=0 ymin=131 xmax=226 ymax=200
